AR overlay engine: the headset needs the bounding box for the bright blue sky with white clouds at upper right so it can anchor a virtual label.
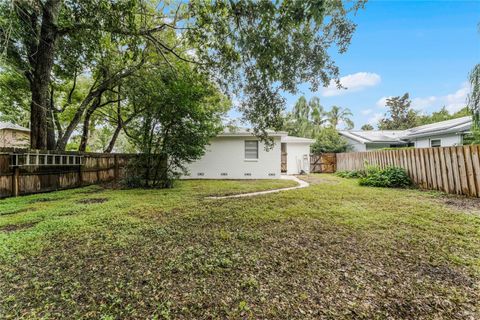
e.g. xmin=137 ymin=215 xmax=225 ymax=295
xmin=231 ymin=0 xmax=480 ymax=129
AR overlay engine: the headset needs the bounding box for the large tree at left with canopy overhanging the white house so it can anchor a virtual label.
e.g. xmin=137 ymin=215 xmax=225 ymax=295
xmin=0 ymin=0 xmax=365 ymax=149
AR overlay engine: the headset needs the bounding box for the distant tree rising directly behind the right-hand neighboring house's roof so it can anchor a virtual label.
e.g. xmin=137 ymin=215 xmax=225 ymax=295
xmin=378 ymin=93 xmax=418 ymax=130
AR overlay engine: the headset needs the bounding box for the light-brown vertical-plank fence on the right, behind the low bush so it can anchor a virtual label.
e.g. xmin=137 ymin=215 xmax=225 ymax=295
xmin=337 ymin=145 xmax=480 ymax=197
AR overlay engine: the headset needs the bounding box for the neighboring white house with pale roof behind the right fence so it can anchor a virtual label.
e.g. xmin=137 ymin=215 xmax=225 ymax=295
xmin=340 ymin=117 xmax=472 ymax=152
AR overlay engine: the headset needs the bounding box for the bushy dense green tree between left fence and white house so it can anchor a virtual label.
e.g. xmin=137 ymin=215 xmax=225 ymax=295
xmin=125 ymin=63 xmax=229 ymax=187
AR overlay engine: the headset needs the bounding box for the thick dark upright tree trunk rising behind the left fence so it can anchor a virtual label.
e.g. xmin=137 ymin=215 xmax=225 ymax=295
xmin=29 ymin=0 xmax=61 ymax=149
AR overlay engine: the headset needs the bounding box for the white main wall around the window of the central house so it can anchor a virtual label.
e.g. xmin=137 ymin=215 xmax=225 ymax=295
xmin=182 ymin=137 xmax=281 ymax=179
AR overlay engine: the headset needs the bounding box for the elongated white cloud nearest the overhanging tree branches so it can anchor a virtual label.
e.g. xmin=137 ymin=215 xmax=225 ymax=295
xmin=322 ymin=72 xmax=382 ymax=97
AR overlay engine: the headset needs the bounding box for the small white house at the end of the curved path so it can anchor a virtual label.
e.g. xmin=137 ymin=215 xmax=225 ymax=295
xmin=183 ymin=129 xmax=314 ymax=179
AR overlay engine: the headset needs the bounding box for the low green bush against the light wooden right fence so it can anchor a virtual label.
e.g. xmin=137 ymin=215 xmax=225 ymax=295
xmin=359 ymin=167 xmax=412 ymax=188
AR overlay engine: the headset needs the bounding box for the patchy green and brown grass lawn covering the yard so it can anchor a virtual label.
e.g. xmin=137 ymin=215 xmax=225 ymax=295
xmin=0 ymin=175 xmax=480 ymax=319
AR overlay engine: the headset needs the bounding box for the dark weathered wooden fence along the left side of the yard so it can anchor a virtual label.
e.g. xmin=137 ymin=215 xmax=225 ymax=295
xmin=0 ymin=149 xmax=135 ymax=198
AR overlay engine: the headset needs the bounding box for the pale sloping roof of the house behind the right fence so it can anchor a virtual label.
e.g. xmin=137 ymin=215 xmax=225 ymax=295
xmin=340 ymin=116 xmax=472 ymax=143
